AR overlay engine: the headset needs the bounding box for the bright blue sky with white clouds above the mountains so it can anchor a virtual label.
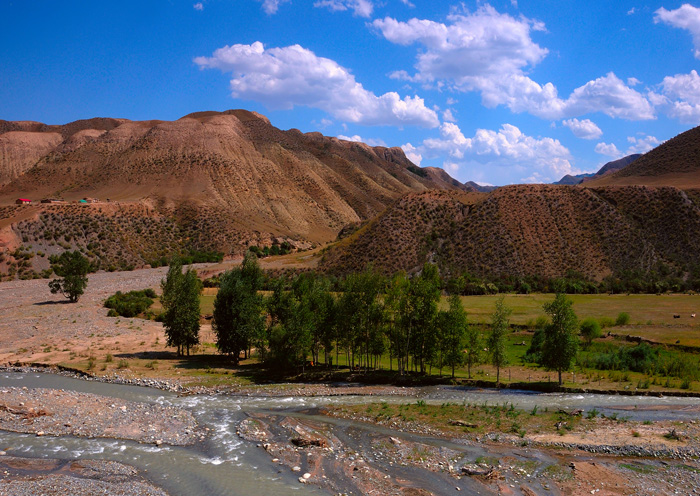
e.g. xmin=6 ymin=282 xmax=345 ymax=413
xmin=0 ymin=0 xmax=700 ymax=185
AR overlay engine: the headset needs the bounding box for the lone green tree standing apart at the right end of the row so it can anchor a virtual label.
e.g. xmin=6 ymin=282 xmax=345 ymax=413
xmin=542 ymin=293 xmax=578 ymax=386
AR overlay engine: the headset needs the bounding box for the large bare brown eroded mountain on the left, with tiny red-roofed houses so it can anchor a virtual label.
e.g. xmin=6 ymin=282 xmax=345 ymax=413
xmin=0 ymin=110 xmax=463 ymax=280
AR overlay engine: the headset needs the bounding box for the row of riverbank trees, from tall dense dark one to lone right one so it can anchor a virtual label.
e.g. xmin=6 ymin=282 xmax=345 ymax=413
xmin=212 ymin=253 xmax=578 ymax=381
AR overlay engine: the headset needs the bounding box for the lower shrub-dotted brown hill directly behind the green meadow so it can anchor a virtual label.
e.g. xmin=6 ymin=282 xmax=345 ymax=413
xmin=320 ymin=185 xmax=700 ymax=280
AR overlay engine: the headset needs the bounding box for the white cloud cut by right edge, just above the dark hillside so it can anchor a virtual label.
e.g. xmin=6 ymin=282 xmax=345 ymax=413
xmin=650 ymin=70 xmax=700 ymax=125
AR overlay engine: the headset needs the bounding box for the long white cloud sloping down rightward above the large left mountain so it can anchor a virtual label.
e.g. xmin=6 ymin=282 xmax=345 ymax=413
xmin=194 ymin=42 xmax=439 ymax=127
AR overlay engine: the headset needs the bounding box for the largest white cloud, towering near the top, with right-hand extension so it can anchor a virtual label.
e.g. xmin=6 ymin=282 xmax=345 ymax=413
xmin=372 ymin=4 xmax=654 ymax=120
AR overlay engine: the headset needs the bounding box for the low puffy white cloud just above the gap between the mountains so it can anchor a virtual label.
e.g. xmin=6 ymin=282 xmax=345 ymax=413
xmin=416 ymin=122 xmax=578 ymax=181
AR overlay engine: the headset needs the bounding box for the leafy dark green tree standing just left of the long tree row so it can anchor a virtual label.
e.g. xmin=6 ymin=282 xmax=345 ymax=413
xmin=161 ymin=259 xmax=202 ymax=356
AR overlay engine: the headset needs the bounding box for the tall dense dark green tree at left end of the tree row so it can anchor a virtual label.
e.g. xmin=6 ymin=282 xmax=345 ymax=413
xmin=212 ymin=251 xmax=265 ymax=365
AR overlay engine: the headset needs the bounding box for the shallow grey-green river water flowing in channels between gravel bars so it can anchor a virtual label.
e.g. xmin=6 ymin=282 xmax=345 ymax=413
xmin=0 ymin=372 xmax=700 ymax=496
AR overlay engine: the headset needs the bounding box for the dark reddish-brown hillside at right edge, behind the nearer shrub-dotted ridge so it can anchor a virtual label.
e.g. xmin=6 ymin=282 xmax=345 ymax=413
xmin=586 ymin=127 xmax=700 ymax=189
